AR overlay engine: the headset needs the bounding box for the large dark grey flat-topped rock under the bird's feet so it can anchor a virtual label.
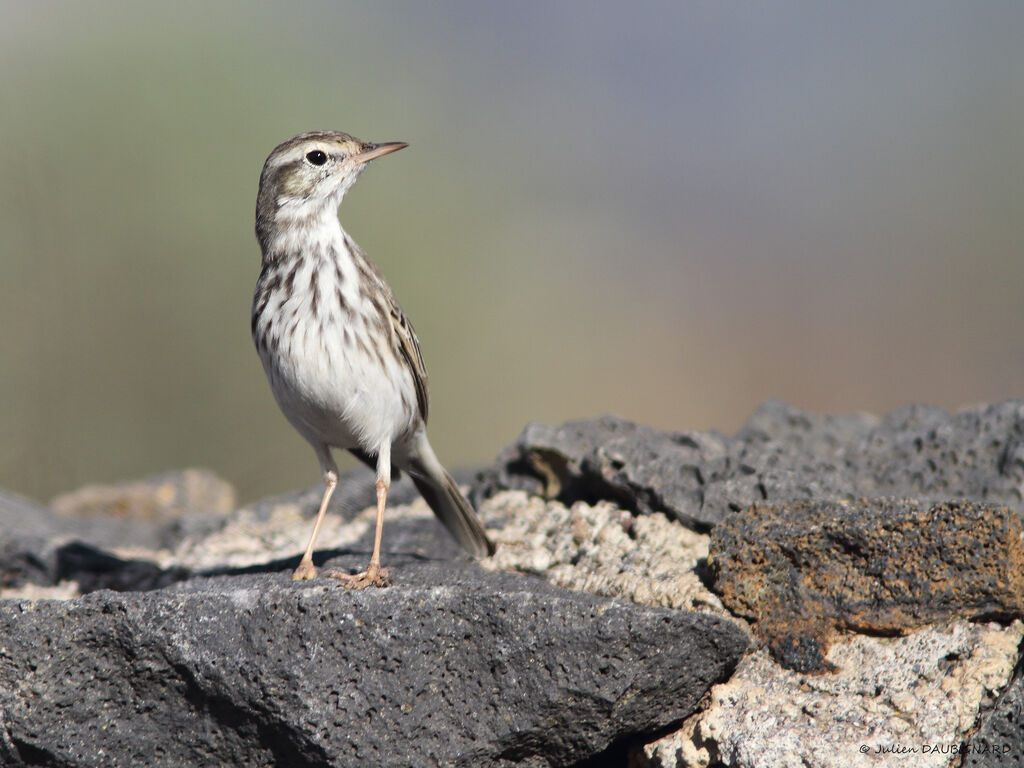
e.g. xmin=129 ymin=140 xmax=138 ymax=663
xmin=0 ymin=558 xmax=746 ymax=768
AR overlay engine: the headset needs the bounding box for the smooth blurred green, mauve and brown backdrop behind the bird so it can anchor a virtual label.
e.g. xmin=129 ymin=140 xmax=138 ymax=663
xmin=0 ymin=0 xmax=1024 ymax=500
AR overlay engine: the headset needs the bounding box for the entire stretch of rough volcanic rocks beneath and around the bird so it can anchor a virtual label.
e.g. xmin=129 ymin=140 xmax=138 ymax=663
xmin=0 ymin=400 xmax=1024 ymax=768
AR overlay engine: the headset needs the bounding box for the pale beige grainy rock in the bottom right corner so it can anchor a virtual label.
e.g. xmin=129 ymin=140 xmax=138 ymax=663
xmin=645 ymin=622 xmax=1024 ymax=768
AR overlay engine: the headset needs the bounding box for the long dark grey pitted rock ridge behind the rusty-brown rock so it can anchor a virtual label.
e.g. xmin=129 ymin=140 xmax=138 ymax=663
xmin=477 ymin=400 xmax=1024 ymax=529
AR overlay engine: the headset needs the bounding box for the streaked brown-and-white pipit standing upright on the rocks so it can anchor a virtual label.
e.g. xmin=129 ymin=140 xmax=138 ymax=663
xmin=252 ymin=131 xmax=494 ymax=588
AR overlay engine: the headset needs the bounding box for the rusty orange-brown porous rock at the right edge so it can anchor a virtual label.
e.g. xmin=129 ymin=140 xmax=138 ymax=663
xmin=708 ymin=500 xmax=1024 ymax=671
